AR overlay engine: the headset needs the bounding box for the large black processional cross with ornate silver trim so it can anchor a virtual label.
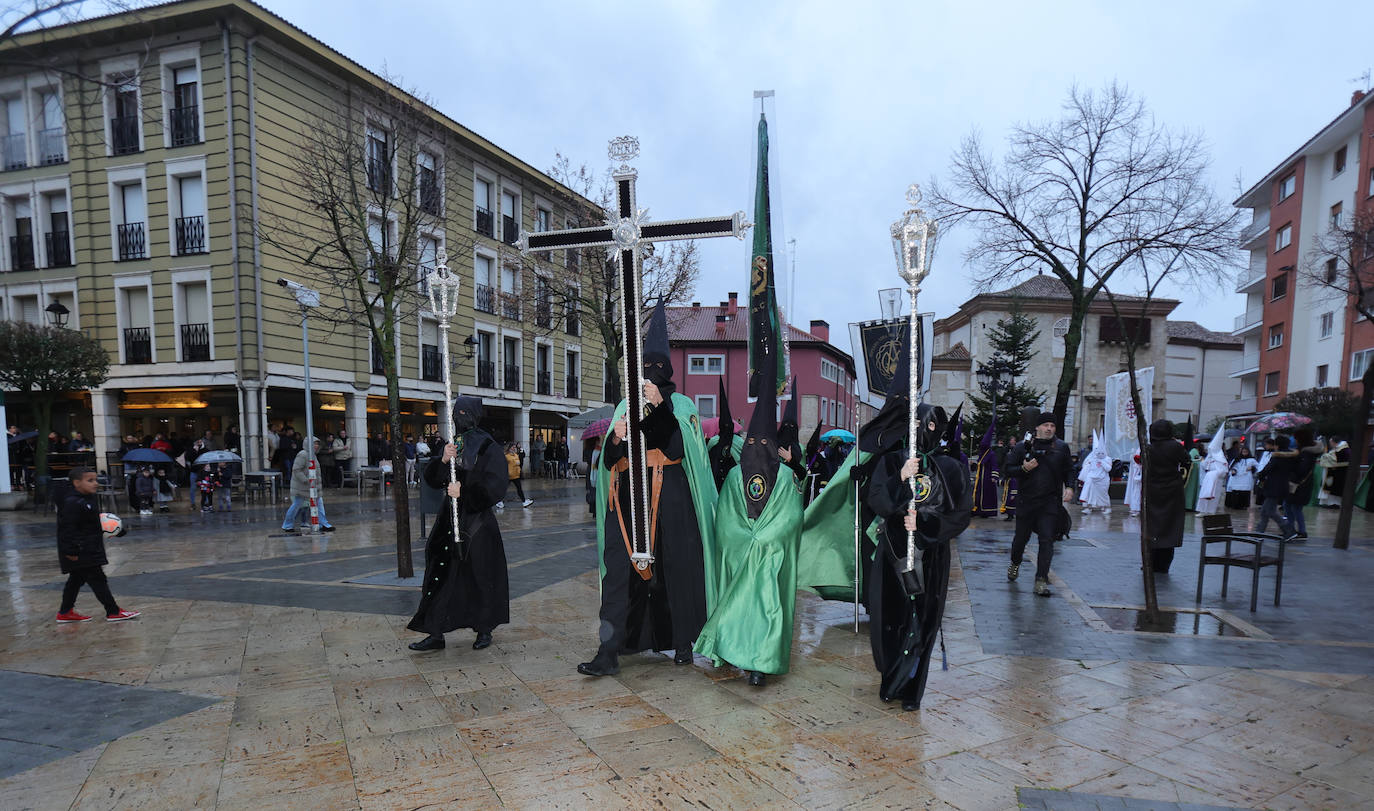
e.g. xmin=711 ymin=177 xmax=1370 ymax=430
xmin=518 ymin=135 xmax=750 ymax=579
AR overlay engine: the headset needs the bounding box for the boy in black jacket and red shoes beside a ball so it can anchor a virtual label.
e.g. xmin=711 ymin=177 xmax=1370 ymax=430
xmin=58 ymin=467 xmax=139 ymax=624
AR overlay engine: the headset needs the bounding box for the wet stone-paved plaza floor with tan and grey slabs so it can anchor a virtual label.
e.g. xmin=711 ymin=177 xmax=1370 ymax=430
xmin=0 ymin=481 xmax=1374 ymax=811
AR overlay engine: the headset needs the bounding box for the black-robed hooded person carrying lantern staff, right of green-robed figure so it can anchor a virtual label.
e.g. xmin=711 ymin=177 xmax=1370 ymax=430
xmin=859 ymin=329 xmax=973 ymax=711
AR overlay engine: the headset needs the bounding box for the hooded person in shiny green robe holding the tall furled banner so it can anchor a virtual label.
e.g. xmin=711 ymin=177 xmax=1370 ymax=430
xmin=697 ymin=357 xmax=801 ymax=687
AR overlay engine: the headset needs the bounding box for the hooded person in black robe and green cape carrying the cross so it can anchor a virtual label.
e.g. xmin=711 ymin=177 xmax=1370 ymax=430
xmin=577 ymin=301 xmax=716 ymax=676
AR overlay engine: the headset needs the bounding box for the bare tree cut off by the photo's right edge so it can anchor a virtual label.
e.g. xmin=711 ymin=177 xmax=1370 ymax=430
xmin=1301 ymin=208 xmax=1374 ymax=548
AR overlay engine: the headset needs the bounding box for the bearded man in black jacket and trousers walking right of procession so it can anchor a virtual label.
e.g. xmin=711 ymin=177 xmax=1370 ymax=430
xmin=1002 ymin=411 xmax=1074 ymax=597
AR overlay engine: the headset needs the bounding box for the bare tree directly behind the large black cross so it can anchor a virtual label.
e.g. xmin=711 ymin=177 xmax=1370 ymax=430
xmin=525 ymin=153 xmax=701 ymax=400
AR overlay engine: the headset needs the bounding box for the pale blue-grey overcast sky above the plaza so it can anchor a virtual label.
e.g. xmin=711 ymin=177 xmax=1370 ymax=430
xmin=260 ymin=0 xmax=1374 ymax=348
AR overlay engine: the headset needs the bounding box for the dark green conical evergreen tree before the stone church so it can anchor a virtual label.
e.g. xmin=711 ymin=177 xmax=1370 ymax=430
xmin=967 ymin=300 xmax=1046 ymax=443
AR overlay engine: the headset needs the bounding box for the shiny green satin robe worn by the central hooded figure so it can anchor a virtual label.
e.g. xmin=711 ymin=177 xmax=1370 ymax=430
xmin=692 ymin=465 xmax=801 ymax=674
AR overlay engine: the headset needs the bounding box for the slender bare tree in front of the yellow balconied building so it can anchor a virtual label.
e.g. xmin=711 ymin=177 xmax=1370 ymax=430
xmin=258 ymin=80 xmax=473 ymax=577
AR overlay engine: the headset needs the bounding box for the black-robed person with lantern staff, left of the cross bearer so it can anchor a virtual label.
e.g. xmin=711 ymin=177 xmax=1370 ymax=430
xmin=407 ymin=396 xmax=511 ymax=650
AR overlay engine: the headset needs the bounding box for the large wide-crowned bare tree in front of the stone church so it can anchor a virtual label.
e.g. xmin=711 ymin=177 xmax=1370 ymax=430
xmin=932 ymin=82 xmax=1239 ymax=430
